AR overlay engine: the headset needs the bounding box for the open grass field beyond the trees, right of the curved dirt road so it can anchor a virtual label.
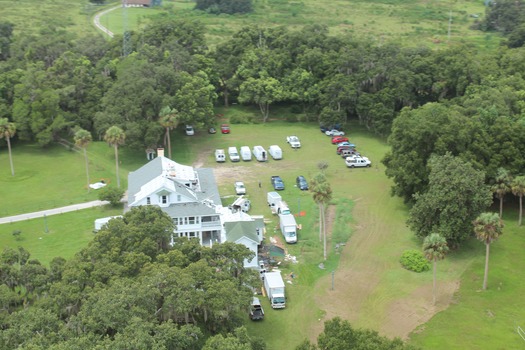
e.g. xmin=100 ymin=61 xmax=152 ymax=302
xmin=96 ymin=0 xmax=499 ymax=49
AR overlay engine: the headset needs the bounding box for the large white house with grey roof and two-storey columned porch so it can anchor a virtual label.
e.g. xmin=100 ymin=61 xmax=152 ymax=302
xmin=128 ymin=152 xmax=262 ymax=267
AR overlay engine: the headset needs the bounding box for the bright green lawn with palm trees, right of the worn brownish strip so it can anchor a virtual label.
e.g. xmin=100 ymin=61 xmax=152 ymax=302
xmin=410 ymin=206 xmax=525 ymax=349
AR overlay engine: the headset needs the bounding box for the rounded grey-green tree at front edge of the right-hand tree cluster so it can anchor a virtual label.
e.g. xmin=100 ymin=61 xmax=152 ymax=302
xmin=407 ymin=153 xmax=492 ymax=245
